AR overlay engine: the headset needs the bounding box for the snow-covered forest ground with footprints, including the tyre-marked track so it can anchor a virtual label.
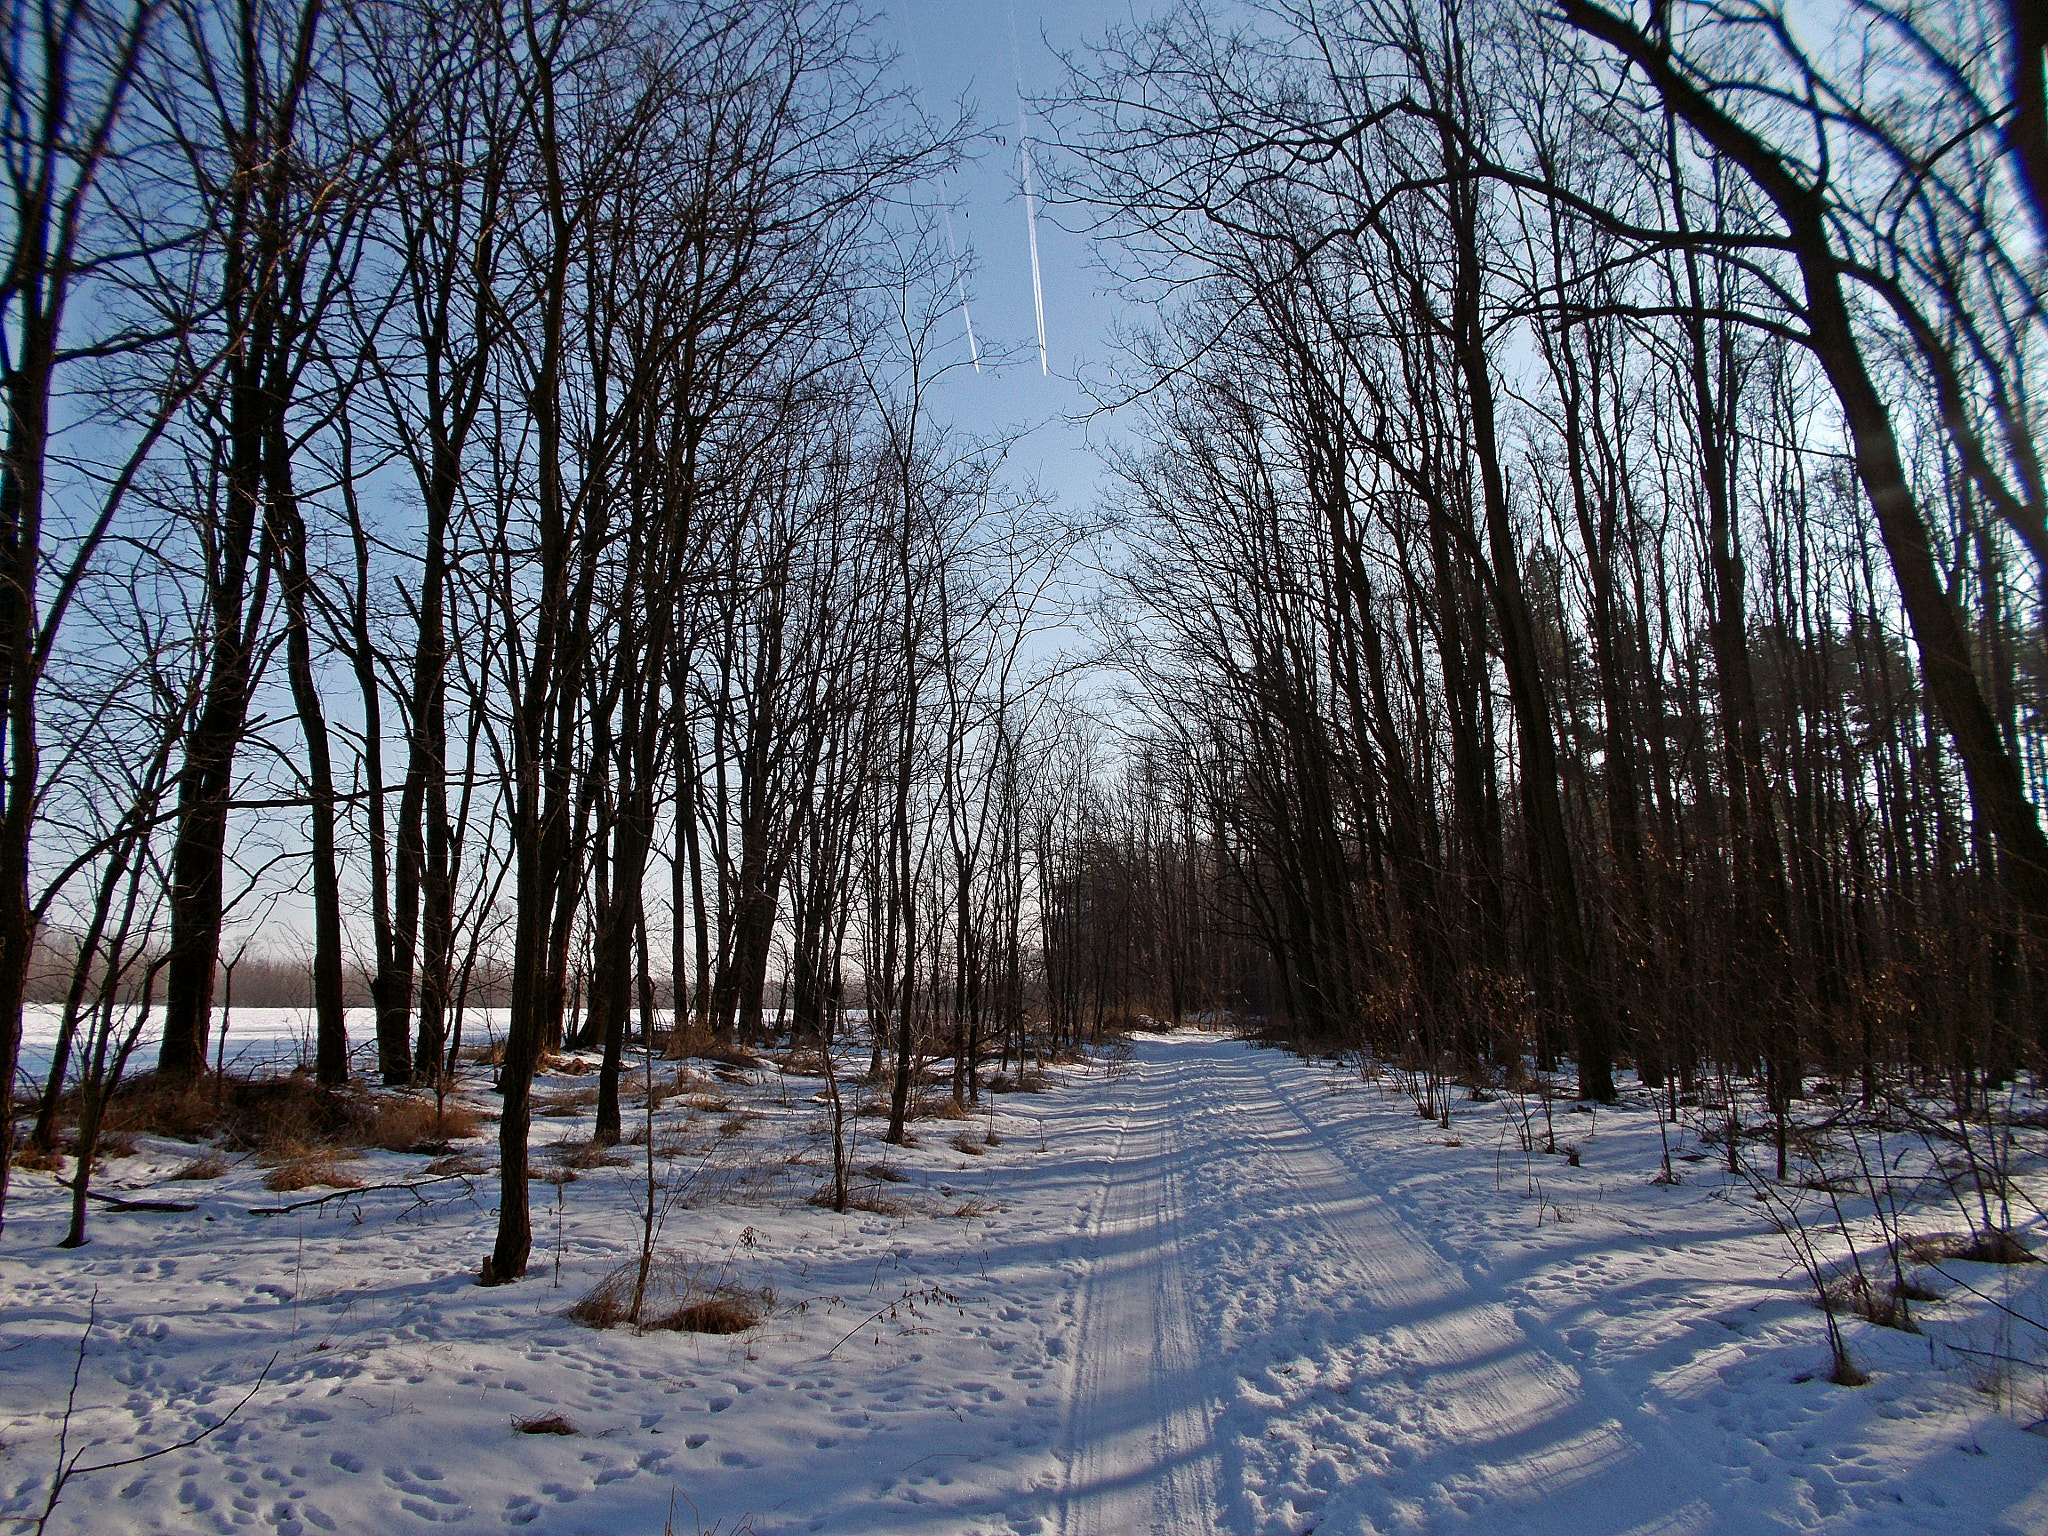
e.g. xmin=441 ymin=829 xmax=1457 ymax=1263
xmin=0 ymin=1034 xmax=2048 ymax=1536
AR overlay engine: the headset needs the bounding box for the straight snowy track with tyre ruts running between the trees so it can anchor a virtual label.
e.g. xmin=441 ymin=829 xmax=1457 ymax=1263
xmin=1040 ymin=1044 xmax=1728 ymax=1536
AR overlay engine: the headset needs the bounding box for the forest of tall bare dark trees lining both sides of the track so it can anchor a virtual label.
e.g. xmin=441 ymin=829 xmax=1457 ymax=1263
xmin=0 ymin=0 xmax=2048 ymax=1528
